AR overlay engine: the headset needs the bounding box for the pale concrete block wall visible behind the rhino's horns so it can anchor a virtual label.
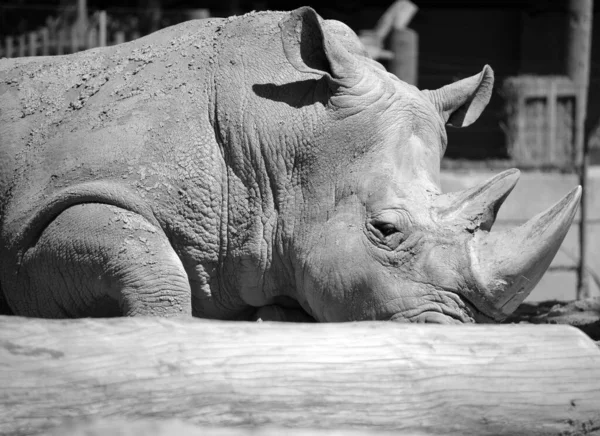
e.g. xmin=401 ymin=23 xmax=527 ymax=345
xmin=442 ymin=166 xmax=600 ymax=301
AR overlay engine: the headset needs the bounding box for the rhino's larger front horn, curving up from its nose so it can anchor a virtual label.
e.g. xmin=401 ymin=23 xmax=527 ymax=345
xmin=470 ymin=186 xmax=581 ymax=320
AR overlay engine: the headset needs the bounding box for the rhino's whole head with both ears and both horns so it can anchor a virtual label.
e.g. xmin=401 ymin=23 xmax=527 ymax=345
xmin=280 ymin=8 xmax=581 ymax=323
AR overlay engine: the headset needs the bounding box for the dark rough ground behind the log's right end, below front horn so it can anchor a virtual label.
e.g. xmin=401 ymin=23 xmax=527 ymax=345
xmin=505 ymin=297 xmax=600 ymax=347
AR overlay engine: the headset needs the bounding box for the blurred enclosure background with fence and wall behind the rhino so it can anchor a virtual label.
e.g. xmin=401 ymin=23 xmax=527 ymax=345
xmin=0 ymin=0 xmax=600 ymax=300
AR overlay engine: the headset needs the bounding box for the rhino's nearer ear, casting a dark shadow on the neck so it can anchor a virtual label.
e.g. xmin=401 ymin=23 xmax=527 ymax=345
xmin=279 ymin=6 xmax=358 ymax=84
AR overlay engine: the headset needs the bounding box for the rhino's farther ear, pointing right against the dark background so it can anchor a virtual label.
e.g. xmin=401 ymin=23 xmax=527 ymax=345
xmin=423 ymin=65 xmax=494 ymax=127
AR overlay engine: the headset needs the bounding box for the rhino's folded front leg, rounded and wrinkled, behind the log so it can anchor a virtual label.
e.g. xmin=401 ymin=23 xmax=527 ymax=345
xmin=9 ymin=203 xmax=192 ymax=317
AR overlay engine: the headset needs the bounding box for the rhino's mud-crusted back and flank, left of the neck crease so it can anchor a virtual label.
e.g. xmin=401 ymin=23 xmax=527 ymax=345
xmin=0 ymin=20 xmax=232 ymax=249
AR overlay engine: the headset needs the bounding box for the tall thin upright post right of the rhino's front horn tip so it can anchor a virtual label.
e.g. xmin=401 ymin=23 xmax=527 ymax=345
xmin=566 ymin=0 xmax=593 ymax=299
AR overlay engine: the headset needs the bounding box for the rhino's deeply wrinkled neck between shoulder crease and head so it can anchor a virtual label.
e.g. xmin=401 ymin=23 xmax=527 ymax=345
xmin=212 ymin=12 xmax=327 ymax=306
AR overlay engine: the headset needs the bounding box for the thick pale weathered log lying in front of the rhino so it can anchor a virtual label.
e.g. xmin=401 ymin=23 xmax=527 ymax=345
xmin=0 ymin=317 xmax=600 ymax=435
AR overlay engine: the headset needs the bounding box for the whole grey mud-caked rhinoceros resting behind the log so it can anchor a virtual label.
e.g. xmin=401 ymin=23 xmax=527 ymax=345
xmin=0 ymin=7 xmax=581 ymax=323
